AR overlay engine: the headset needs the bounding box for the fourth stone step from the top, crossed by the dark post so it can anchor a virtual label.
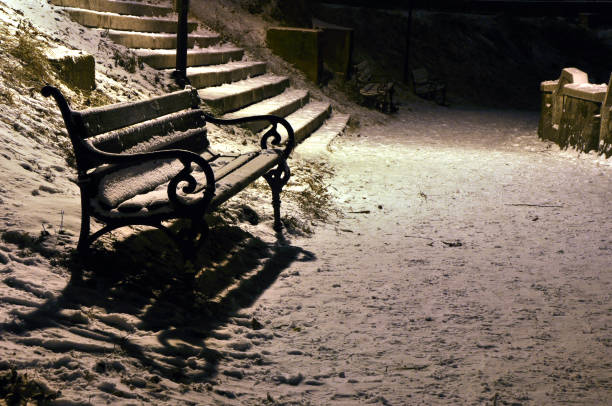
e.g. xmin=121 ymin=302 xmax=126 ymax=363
xmin=134 ymin=45 xmax=244 ymax=69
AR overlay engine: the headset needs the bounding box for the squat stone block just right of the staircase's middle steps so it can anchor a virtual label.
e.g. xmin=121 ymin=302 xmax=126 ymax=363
xmin=266 ymin=27 xmax=322 ymax=83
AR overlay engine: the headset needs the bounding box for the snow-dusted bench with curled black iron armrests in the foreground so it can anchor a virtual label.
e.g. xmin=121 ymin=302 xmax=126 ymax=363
xmin=42 ymin=86 xmax=295 ymax=254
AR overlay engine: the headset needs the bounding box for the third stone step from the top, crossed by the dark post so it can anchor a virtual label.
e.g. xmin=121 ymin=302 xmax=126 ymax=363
xmin=108 ymin=30 xmax=220 ymax=49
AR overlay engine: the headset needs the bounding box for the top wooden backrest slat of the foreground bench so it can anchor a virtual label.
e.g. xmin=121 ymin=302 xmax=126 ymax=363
xmin=75 ymin=89 xmax=199 ymax=138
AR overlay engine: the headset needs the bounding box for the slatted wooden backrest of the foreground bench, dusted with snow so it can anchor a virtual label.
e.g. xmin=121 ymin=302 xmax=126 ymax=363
xmin=72 ymin=88 xmax=208 ymax=165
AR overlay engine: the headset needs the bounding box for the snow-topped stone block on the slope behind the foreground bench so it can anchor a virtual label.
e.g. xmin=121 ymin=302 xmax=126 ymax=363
xmin=46 ymin=46 xmax=96 ymax=90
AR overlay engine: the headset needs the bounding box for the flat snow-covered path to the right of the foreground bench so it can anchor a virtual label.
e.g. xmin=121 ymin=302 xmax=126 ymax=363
xmin=219 ymin=109 xmax=612 ymax=405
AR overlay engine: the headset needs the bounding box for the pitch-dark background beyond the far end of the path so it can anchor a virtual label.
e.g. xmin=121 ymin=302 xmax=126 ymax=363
xmin=243 ymin=0 xmax=612 ymax=109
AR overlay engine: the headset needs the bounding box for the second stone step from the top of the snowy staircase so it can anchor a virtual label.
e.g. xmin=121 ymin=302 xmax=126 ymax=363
xmin=65 ymin=8 xmax=198 ymax=33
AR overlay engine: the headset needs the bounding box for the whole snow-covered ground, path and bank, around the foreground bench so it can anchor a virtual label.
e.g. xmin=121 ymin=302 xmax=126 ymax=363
xmin=0 ymin=2 xmax=612 ymax=405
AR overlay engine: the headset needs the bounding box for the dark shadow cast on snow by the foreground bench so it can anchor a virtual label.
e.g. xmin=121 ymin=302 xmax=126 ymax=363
xmin=5 ymin=220 xmax=315 ymax=382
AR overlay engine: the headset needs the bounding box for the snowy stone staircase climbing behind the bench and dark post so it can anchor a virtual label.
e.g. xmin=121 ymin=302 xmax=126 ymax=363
xmin=49 ymin=0 xmax=347 ymax=151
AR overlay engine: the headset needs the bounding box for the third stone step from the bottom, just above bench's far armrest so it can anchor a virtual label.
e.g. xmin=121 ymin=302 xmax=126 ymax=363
xmin=223 ymin=89 xmax=310 ymax=131
